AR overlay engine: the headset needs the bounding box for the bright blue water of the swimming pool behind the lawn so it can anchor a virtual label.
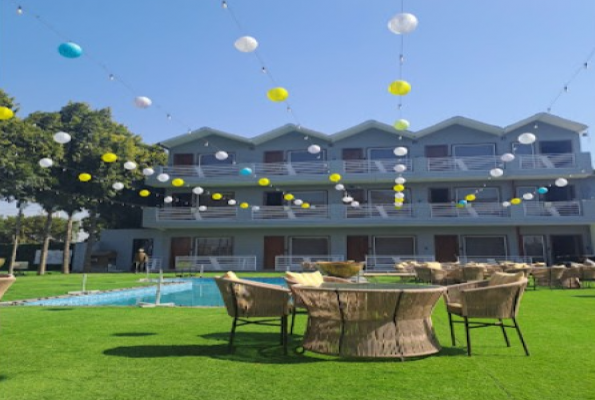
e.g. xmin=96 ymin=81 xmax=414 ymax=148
xmin=22 ymin=278 xmax=285 ymax=307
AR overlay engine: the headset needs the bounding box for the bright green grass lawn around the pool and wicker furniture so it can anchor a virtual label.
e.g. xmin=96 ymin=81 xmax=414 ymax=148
xmin=0 ymin=274 xmax=595 ymax=400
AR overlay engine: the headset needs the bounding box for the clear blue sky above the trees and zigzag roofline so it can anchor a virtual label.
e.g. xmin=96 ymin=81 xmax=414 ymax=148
xmin=0 ymin=0 xmax=595 ymax=216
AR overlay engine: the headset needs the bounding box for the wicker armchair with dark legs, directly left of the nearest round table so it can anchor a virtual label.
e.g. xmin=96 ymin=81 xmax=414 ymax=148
xmin=215 ymin=277 xmax=291 ymax=354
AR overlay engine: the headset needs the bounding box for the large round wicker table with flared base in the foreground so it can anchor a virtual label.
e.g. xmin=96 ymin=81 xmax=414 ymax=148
xmin=291 ymin=283 xmax=445 ymax=359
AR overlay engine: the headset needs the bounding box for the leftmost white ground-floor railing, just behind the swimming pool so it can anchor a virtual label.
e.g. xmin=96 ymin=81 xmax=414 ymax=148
xmin=175 ymin=256 xmax=256 ymax=271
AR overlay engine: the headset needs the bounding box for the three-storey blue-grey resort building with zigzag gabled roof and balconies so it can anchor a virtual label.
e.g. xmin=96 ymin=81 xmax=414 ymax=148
xmin=88 ymin=113 xmax=595 ymax=270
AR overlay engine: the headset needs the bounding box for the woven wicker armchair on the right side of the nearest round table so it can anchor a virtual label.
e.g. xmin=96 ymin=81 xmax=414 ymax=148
xmin=445 ymin=278 xmax=529 ymax=356
